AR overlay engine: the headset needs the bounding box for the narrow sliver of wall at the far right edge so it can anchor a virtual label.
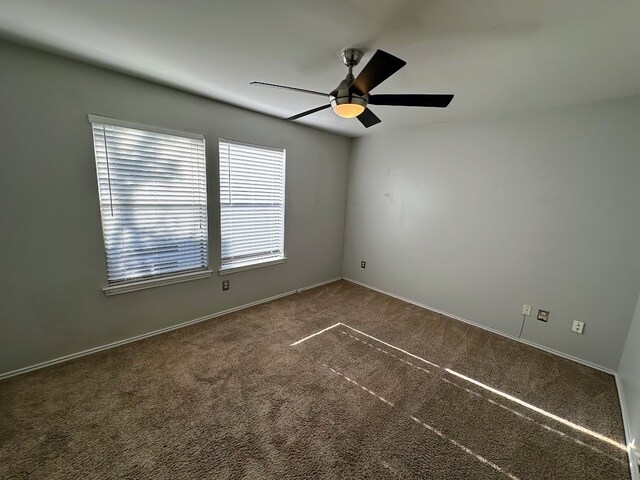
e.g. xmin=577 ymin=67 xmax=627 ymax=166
xmin=618 ymin=292 xmax=640 ymax=459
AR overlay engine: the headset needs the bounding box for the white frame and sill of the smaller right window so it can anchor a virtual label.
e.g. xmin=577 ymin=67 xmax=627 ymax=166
xmin=217 ymin=137 xmax=287 ymax=275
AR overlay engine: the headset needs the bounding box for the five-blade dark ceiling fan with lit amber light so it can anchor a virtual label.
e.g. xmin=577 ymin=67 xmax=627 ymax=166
xmin=251 ymin=48 xmax=453 ymax=128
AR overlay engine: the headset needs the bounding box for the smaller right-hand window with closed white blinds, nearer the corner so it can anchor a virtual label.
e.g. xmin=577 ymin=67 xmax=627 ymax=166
xmin=220 ymin=139 xmax=285 ymax=273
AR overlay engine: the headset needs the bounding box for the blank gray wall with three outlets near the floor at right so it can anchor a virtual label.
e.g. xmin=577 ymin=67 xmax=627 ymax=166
xmin=343 ymin=97 xmax=640 ymax=369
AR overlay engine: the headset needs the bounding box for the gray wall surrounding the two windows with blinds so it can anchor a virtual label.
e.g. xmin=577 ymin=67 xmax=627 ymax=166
xmin=0 ymin=42 xmax=350 ymax=373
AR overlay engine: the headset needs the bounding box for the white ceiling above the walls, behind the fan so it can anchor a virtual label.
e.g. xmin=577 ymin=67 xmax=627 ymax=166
xmin=0 ymin=0 xmax=640 ymax=136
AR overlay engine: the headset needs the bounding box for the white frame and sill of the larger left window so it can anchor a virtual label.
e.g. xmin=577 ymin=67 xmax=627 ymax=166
xmin=88 ymin=114 xmax=213 ymax=296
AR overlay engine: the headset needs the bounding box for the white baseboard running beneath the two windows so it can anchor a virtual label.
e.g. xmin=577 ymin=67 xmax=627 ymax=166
xmin=0 ymin=277 xmax=342 ymax=380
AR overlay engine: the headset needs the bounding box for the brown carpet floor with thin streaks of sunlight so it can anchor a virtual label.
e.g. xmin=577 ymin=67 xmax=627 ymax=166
xmin=0 ymin=281 xmax=630 ymax=480
